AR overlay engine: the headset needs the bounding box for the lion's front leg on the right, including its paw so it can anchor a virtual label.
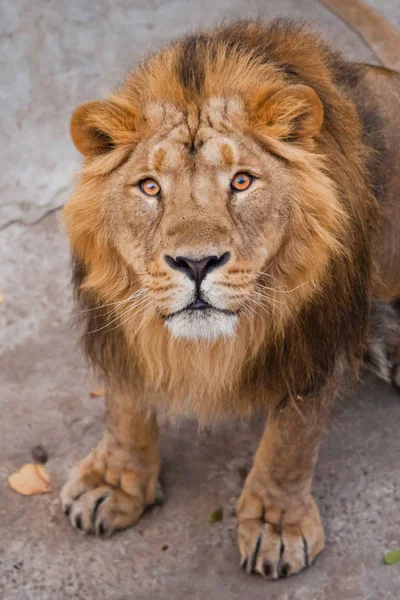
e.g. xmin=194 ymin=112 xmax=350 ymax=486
xmin=237 ymin=398 xmax=324 ymax=579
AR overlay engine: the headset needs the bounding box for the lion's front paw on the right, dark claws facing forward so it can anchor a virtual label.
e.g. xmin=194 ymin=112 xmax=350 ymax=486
xmin=238 ymin=496 xmax=325 ymax=579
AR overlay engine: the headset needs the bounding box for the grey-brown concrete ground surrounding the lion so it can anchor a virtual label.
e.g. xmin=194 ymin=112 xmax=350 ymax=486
xmin=0 ymin=0 xmax=400 ymax=600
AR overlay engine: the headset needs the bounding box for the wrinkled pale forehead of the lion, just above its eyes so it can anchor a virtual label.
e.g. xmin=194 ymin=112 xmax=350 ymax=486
xmin=145 ymin=97 xmax=244 ymax=171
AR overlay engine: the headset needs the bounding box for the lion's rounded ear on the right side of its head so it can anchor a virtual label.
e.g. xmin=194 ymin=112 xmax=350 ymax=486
xmin=257 ymin=85 xmax=324 ymax=143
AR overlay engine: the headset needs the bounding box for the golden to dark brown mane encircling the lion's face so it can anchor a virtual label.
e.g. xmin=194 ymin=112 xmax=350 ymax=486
xmin=64 ymin=22 xmax=378 ymax=421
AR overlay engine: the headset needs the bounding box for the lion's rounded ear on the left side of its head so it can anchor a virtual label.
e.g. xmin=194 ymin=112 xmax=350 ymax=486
xmin=71 ymin=99 xmax=137 ymax=156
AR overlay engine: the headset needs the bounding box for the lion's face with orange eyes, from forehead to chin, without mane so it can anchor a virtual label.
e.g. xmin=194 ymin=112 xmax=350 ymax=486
xmin=96 ymin=99 xmax=291 ymax=339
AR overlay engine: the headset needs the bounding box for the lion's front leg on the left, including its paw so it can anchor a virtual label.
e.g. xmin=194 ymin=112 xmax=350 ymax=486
xmin=61 ymin=394 xmax=160 ymax=536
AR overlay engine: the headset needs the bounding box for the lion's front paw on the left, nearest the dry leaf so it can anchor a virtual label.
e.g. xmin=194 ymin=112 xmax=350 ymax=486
xmin=60 ymin=449 xmax=162 ymax=537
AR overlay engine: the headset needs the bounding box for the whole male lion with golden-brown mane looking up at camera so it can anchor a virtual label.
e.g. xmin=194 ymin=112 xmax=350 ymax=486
xmin=61 ymin=20 xmax=400 ymax=579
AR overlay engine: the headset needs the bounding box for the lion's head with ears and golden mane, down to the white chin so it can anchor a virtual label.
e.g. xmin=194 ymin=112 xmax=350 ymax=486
xmin=65 ymin=23 xmax=378 ymax=412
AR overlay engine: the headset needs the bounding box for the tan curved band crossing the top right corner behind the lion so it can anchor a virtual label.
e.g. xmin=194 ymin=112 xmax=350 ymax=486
xmin=320 ymin=0 xmax=400 ymax=71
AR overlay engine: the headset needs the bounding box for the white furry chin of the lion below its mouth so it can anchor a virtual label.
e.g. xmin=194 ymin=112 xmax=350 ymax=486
xmin=165 ymin=309 xmax=238 ymax=342
